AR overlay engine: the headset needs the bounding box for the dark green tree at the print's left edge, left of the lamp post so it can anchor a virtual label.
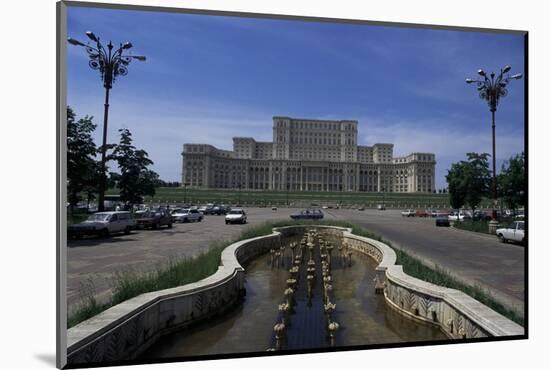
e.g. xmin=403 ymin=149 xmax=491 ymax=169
xmin=67 ymin=107 xmax=99 ymax=206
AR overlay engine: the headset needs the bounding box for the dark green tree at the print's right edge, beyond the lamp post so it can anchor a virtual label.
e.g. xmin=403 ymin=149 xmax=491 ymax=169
xmin=498 ymin=152 xmax=527 ymax=210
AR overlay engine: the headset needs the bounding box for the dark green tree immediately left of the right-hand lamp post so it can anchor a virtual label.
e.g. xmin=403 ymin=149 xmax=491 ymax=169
xmin=446 ymin=153 xmax=491 ymax=209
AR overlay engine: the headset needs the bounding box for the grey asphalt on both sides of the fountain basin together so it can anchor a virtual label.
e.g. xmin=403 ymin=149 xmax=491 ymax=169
xmin=67 ymin=208 xmax=525 ymax=312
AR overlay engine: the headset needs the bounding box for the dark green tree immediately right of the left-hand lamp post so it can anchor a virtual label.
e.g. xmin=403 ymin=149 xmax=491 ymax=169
xmin=111 ymin=129 xmax=159 ymax=205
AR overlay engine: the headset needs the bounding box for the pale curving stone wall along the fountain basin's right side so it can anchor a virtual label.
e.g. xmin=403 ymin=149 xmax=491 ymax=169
xmin=343 ymin=229 xmax=525 ymax=339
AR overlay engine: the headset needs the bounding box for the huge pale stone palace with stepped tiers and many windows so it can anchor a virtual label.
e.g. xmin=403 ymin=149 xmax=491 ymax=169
xmin=182 ymin=116 xmax=435 ymax=193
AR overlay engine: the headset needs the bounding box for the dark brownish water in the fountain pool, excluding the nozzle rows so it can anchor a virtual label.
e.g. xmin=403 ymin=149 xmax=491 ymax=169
xmin=142 ymin=238 xmax=447 ymax=358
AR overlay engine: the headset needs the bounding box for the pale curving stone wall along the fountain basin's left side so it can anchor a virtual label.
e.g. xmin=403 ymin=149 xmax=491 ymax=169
xmin=67 ymin=232 xmax=281 ymax=365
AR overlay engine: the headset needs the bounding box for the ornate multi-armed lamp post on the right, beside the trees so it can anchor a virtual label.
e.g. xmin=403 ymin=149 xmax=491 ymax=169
xmin=466 ymin=65 xmax=522 ymax=233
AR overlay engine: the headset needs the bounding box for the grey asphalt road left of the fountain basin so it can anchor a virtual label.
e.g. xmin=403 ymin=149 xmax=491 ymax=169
xmin=67 ymin=208 xmax=306 ymax=312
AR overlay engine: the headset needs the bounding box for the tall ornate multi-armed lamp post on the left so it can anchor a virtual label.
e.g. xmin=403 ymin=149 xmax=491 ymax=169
xmin=67 ymin=31 xmax=145 ymax=212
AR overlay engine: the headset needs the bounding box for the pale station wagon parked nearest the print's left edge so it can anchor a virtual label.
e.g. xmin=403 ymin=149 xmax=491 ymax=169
xmin=67 ymin=211 xmax=136 ymax=238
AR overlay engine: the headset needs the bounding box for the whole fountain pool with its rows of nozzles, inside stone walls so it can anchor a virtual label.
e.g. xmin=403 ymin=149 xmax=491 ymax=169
xmin=142 ymin=225 xmax=448 ymax=357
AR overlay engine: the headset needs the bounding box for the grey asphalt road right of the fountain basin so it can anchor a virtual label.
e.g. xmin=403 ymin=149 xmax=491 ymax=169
xmin=326 ymin=210 xmax=525 ymax=313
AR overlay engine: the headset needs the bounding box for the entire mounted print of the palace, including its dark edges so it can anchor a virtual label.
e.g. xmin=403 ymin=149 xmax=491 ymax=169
xmin=57 ymin=1 xmax=529 ymax=368
